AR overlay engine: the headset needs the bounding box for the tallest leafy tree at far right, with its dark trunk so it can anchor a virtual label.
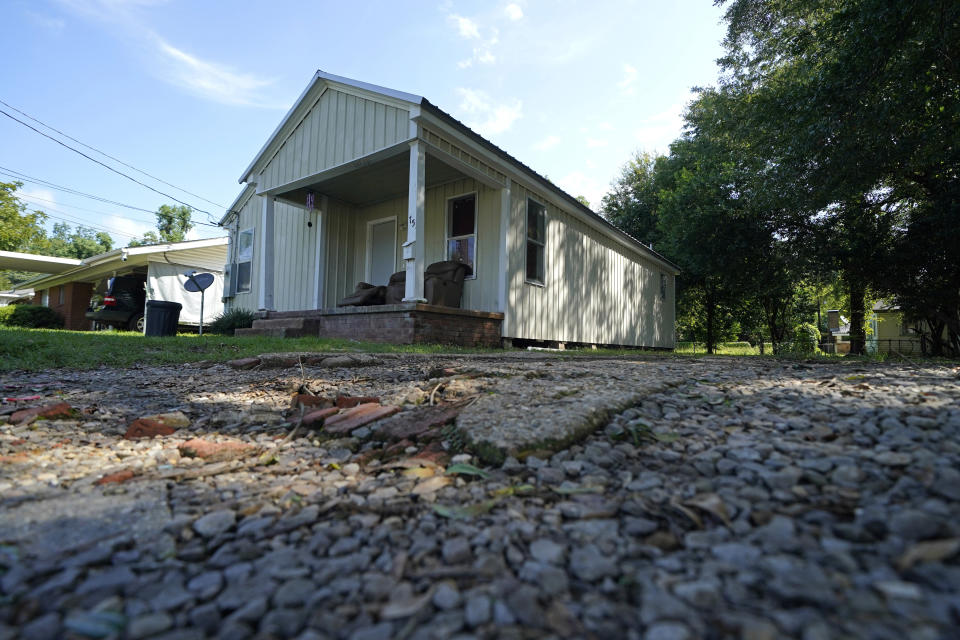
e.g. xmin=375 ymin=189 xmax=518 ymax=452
xmin=720 ymin=0 xmax=960 ymax=352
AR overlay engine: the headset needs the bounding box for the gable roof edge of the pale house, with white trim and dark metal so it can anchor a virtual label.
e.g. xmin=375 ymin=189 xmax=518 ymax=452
xmin=235 ymin=70 xmax=680 ymax=275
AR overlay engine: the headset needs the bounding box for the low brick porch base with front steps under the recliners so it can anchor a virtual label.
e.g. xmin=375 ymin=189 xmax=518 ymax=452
xmin=236 ymin=303 xmax=503 ymax=347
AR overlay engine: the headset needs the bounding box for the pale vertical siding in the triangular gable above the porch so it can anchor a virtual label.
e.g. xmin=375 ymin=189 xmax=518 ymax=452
xmin=256 ymin=88 xmax=410 ymax=191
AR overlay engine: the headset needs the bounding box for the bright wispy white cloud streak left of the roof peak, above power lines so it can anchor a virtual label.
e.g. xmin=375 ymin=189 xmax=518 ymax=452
xmin=154 ymin=36 xmax=275 ymax=106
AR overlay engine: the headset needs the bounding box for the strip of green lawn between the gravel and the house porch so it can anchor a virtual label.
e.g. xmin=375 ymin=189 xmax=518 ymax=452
xmin=0 ymin=326 xmax=488 ymax=371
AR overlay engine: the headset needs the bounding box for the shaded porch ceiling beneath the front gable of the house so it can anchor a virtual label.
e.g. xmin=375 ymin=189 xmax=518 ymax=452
xmin=277 ymin=153 xmax=467 ymax=206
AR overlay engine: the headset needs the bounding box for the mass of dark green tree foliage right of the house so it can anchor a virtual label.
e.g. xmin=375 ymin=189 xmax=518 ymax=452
xmin=603 ymin=0 xmax=960 ymax=355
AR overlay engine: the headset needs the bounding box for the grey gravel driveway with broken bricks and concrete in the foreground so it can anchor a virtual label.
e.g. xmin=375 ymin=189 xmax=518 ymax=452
xmin=0 ymin=354 xmax=960 ymax=640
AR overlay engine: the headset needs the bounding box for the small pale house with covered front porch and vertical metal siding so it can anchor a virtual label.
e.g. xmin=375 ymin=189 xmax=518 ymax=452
xmin=221 ymin=71 xmax=678 ymax=349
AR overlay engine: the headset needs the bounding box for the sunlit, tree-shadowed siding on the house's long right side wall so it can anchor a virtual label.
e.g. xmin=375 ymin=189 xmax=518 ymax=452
xmin=503 ymin=182 xmax=674 ymax=348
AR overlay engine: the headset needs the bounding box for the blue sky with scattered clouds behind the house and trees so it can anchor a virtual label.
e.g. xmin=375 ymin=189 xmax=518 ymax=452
xmin=0 ymin=0 xmax=723 ymax=245
